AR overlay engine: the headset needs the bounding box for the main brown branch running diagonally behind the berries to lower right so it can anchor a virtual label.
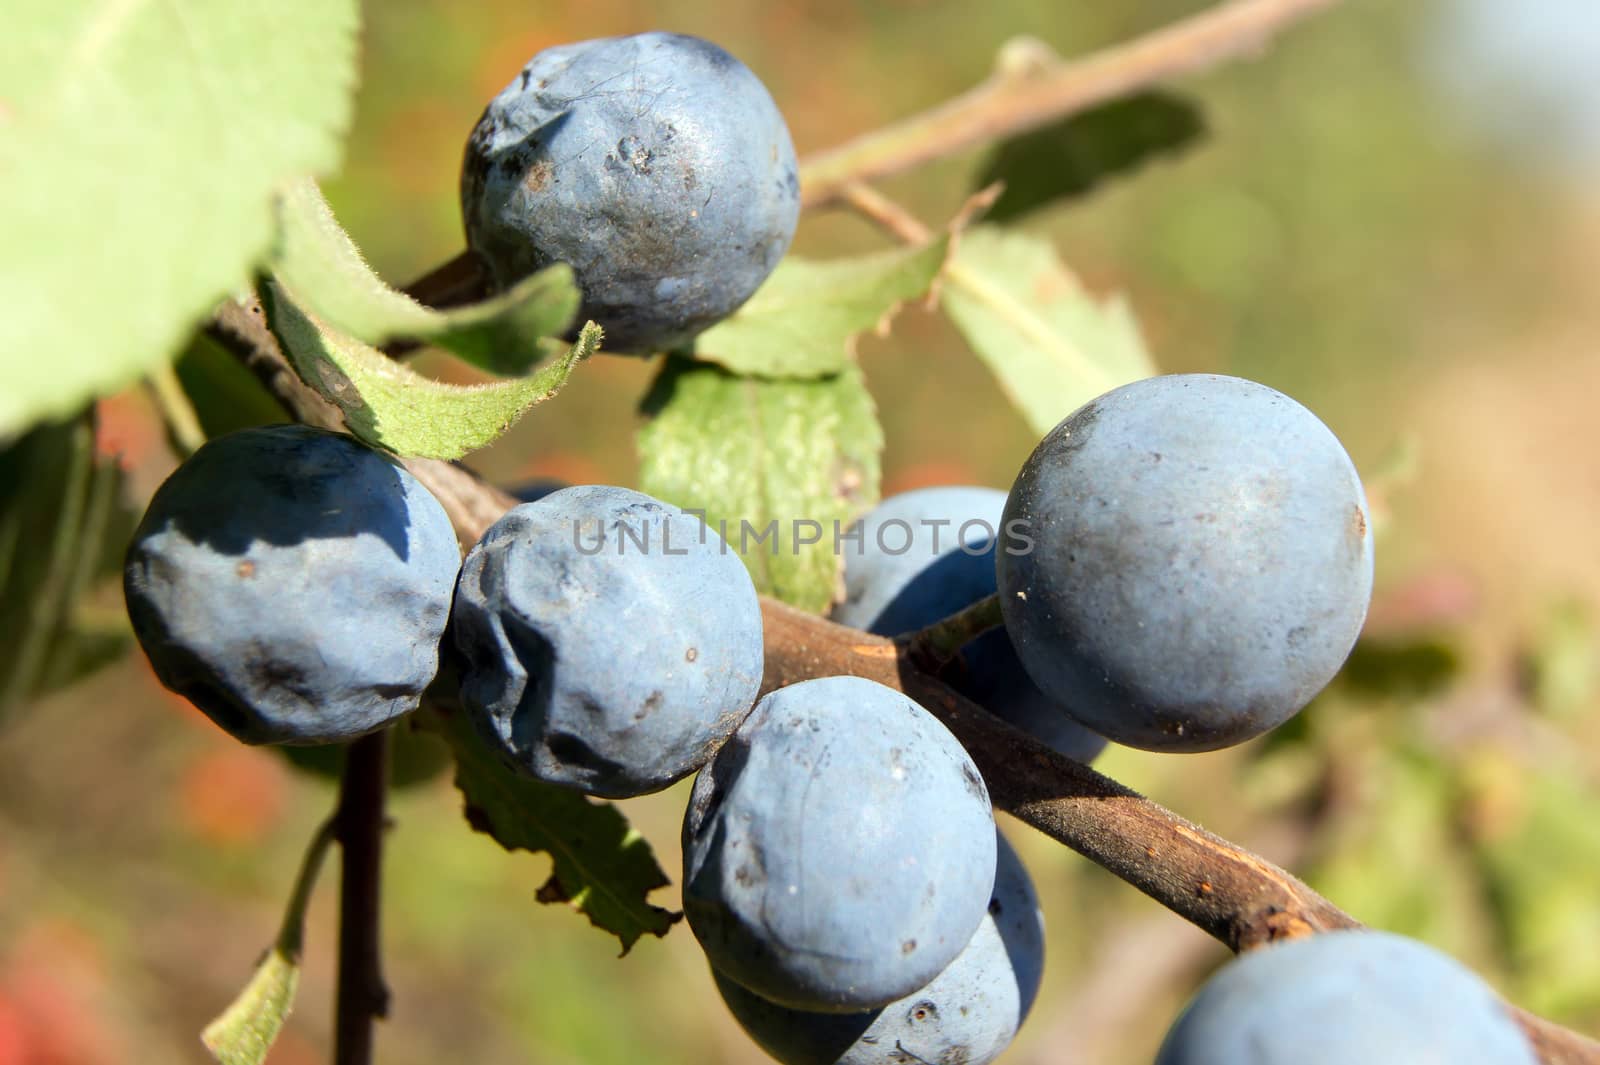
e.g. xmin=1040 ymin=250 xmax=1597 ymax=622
xmin=213 ymin=286 xmax=1600 ymax=1065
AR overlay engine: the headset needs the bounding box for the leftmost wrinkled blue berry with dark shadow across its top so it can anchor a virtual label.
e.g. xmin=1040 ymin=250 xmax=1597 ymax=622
xmin=123 ymin=425 xmax=461 ymax=744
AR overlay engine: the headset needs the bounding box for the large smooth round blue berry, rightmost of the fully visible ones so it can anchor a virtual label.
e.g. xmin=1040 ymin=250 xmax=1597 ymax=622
xmin=997 ymin=374 xmax=1373 ymax=752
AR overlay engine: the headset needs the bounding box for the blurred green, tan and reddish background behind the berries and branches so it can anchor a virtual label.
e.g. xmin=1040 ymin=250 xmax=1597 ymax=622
xmin=0 ymin=0 xmax=1600 ymax=1065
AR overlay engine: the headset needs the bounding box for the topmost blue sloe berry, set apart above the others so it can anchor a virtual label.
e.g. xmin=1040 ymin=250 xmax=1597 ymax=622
xmin=461 ymin=32 xmax=800 ymax=353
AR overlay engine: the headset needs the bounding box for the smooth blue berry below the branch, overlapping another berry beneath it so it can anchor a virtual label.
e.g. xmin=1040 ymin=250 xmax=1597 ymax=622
xmin=683 ymin=676 xmax=995 ymax=1012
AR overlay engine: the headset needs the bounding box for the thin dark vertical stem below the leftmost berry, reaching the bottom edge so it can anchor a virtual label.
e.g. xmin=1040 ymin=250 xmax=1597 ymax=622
xmin=333 ymin=729 xmax=389 ymax=1065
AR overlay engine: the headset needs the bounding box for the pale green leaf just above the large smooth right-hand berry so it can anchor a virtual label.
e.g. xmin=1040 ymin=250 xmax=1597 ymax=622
xmin=942 ymin=225 xmax=1155 ymax=437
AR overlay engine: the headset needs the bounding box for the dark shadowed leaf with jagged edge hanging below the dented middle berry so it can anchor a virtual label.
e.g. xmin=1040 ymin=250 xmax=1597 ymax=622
xmin=424 ymin=705 xmax=683 ymax=955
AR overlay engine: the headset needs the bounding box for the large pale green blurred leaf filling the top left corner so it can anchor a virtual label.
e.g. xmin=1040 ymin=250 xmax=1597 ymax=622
xmin=0 ymin=0 xmax=358 ymax=438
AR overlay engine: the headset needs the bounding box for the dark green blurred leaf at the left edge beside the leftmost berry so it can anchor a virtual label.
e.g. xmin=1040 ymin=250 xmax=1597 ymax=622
xmin=0 ymin=414 xmax=133 ymax=716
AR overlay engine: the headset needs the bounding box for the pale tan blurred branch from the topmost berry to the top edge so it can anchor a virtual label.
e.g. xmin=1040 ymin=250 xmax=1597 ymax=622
xmin=800 ymin=0 xmax=1339 ymax=206
